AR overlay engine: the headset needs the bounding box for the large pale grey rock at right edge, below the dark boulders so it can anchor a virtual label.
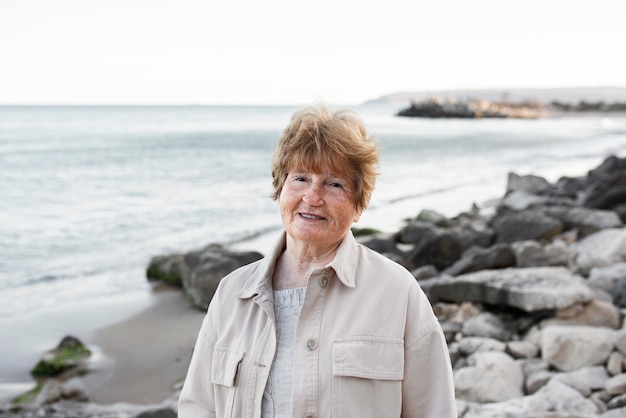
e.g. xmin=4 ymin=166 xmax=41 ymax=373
xmin=572 ymin=228 xmax=626 ymax=272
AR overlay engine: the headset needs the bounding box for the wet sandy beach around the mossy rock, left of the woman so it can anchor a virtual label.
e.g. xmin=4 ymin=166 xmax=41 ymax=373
xmin=0 ymin=288 xmax=204 ymax=405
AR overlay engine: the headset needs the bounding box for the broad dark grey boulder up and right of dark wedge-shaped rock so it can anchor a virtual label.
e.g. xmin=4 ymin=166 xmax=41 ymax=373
xmin=492 ymin=209 xmax=564 ymax=243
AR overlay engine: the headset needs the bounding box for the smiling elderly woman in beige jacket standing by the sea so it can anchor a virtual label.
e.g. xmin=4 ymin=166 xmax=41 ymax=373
xmin=178 ymin=106 xmax=457 ymax=418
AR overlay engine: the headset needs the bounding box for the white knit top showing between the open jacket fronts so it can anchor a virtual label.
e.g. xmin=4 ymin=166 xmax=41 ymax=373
xmin=261 ymin=287 xmax=306 ymax=418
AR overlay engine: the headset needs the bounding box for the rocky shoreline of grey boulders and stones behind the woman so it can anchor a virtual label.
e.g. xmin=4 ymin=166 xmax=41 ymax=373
xmin=0 ymin=156 xmax=626 ymax=418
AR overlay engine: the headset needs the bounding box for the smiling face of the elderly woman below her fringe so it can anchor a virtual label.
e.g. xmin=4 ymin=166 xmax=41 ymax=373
xmin=279 ymin=167 xmax=361 ymax=250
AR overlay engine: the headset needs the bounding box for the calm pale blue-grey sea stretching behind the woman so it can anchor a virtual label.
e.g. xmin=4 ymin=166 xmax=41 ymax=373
xmin=0 ymin=103 xmax=626 ymax=319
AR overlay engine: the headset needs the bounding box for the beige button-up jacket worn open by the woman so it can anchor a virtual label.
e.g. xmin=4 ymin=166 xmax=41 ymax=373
xmin=178 ymin=233 xmax=457 ymax=418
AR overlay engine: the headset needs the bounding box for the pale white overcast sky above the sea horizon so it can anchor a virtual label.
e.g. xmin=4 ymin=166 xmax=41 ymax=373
xmin=0 ymin=0 xmax=626 ymax=104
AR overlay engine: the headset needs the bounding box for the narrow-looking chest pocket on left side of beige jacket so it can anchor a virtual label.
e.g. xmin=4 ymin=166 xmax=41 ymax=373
xmin=211 ymin=346 xmax=245 ymax=417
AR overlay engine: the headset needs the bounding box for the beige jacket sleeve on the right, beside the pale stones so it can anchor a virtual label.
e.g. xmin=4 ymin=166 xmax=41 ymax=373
xmin=402 ymin=287 xmax=457 ymax=418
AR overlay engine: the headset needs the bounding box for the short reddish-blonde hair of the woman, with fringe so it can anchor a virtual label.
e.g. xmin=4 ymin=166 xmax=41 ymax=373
xmin=272 ymin=105 xmax=378 ymax=211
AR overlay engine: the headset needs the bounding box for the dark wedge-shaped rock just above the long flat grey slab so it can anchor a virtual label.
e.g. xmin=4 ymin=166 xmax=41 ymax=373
xmin=443 ymin=244 xmax=515 ymax=276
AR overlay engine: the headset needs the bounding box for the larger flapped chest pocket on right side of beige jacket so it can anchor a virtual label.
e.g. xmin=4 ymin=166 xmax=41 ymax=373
xmin=333 ymin=336 xmax=404 ymax=418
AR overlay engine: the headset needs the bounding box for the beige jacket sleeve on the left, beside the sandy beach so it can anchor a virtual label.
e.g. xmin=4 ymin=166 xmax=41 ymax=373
xmin=178 ymin=308 xmax=215 ymax=418
